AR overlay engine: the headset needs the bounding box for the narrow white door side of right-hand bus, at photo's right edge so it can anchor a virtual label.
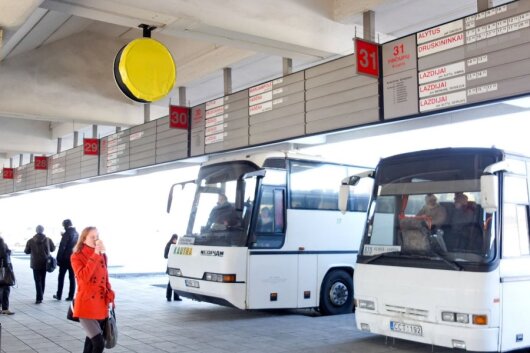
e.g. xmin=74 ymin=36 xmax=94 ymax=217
xmin=500 ymin=176 xmax=530 ymax=352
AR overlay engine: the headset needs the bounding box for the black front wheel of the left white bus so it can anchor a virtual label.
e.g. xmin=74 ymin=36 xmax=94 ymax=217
xmin=320 ymin=270 xmax=353 ymax=315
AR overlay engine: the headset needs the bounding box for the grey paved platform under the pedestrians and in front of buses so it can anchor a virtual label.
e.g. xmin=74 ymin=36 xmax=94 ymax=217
xmin=0 ymin=256 xmax=451 ymax=353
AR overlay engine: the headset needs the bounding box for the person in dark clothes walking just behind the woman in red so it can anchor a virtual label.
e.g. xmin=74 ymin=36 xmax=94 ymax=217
xmin=53 ymin=219 xmax=79 ymax=301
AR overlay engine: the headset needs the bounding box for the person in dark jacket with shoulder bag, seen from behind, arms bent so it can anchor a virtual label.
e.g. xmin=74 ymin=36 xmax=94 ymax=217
xmin=24 ymin=225 xmax=55 ymax=304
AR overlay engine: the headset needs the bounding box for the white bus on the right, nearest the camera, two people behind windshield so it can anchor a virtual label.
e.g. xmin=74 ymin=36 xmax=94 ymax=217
xmin=340 ymin=148 xmax=530 ymax=352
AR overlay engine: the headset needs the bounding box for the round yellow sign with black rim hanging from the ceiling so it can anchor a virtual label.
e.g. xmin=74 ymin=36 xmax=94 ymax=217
xmin=114 ymin=38 xmax=177 ymax=103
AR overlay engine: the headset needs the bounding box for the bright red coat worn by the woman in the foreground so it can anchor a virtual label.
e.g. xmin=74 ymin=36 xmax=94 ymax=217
xmin=70 ymin=245 xmax=114 ymax=320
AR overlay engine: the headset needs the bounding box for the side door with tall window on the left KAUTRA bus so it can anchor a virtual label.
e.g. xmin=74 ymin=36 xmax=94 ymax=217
xmin=247 ymin=185 xmax=292 ymax=309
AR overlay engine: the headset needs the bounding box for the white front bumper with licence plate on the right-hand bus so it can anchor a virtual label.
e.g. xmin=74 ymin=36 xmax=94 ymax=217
xmin=355 ymin=309 xmax=499 ymax=352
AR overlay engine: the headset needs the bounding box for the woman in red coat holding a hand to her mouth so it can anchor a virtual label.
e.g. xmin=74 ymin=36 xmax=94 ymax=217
xmin=71 ymin=227 xmax=114 ymax=353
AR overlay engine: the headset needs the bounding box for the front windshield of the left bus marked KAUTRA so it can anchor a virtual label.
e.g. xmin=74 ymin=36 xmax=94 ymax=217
xmin=185 ymin=162 xmax=258 ymax=246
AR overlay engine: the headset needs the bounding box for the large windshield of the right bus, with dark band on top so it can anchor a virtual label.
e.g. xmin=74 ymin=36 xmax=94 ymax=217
xmin=360 ymin=153 xmax=495 ymax=270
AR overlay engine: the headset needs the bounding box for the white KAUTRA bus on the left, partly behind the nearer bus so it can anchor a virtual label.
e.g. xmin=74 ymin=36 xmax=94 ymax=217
xmin=168 ymin=152 xmax=369 ymax=314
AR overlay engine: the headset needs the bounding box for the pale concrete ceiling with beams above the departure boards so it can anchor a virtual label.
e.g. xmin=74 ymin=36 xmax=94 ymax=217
xmin=0 ymin=0 xmax=507 ymax=167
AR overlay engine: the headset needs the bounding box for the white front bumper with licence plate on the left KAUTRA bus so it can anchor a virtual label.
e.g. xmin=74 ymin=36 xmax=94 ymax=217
xmin=169 ymin=276 xmax=246 ymax=309
